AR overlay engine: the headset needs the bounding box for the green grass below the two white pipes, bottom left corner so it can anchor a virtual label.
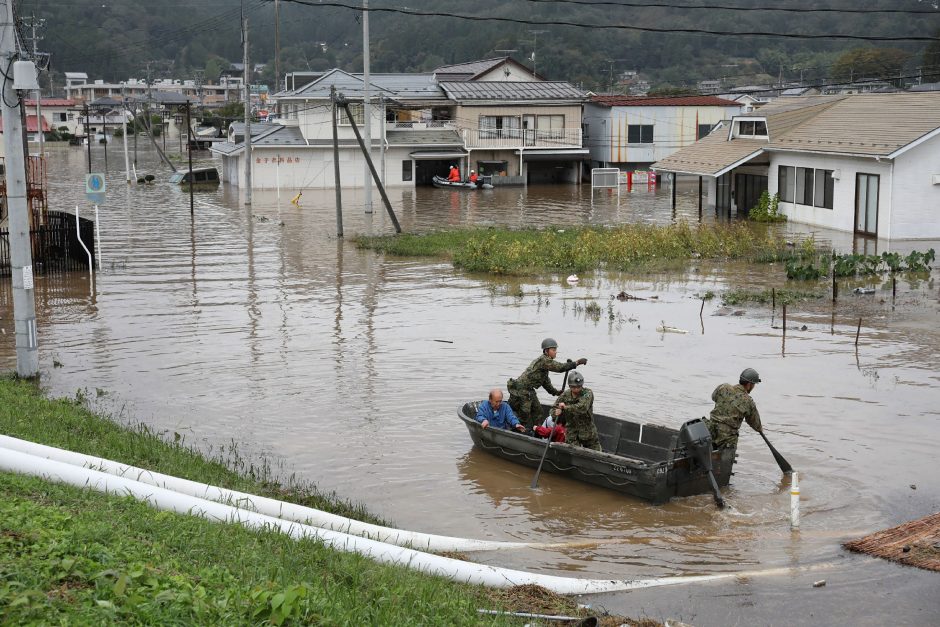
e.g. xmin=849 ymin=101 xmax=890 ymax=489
xmin=0 ymin=473 xmax=507 ymax=625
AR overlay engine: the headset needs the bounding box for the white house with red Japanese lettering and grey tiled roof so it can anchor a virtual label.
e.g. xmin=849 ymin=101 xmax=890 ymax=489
xmin=212 ymin=69 xmax=467 ymax=189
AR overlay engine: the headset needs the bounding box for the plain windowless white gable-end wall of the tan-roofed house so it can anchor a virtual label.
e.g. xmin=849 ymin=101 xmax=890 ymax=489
xmin=886 ymin=137 xmax=940 ymax=239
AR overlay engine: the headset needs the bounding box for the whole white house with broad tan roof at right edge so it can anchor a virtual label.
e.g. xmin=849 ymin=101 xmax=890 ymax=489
xmin=653 ymin=92 xmax=940 ymax=239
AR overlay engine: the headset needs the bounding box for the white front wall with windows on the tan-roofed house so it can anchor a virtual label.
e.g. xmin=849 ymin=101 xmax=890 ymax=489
xmin=767 ymin=152 xmax=892 ymax=238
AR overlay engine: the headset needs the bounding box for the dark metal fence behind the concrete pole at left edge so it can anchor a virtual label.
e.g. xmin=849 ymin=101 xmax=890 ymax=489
xmin=0 ymin=211 xmax=95 ymax=276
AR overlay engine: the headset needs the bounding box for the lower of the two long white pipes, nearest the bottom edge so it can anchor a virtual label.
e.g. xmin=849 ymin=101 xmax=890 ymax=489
xmin=0 ymin=448 xmax=739 ymax=594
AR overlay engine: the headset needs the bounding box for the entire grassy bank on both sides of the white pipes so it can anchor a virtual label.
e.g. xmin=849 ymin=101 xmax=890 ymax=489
xmin=0 ymin=377 xmax=659 ymax=625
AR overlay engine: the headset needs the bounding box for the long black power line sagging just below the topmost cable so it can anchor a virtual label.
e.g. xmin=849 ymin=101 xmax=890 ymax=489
xmin=272 ymin=0 xmax=940 ymax=41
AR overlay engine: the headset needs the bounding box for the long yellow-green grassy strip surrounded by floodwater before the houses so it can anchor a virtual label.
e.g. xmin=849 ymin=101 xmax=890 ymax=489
xmin=355 ymin=223 xmax=788 ymax=275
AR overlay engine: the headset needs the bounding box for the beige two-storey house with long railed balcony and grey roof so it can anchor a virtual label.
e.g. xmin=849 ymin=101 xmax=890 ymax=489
xmin=440 ymin=81 xmax=588 ymax=184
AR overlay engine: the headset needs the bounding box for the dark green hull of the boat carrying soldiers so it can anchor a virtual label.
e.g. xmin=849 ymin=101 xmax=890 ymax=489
xmin=458 ymin=403 xmax=735 ymax=505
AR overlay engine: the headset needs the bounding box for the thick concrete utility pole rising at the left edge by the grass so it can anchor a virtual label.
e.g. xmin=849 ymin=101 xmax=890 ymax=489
xmin=0 ymin=0 xmax=39 ymax=377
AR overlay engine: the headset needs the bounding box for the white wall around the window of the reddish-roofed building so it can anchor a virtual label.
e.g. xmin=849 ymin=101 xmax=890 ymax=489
xmin=584 ymin=103 xmax=740 ymax=164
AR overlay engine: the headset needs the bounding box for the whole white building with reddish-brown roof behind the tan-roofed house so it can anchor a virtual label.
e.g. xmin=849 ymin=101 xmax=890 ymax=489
xmin=583 ymin=96 xmax=741 ymax=170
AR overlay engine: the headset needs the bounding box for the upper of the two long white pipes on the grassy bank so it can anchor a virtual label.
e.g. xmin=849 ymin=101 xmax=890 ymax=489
xmin=0 ymin=435 xmax=560 ymax=551
